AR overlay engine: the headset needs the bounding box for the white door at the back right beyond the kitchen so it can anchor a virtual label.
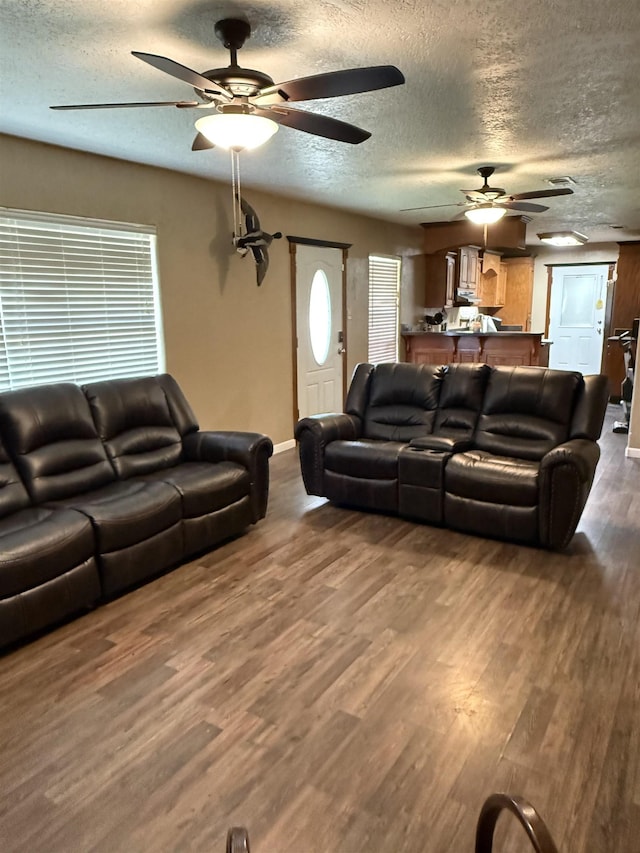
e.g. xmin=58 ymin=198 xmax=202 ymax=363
xmin=549 ymin=265 xmax=609 ymax=374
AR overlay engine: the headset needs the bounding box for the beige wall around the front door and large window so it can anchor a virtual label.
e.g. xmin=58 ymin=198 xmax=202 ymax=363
xmin=0 ymin=135 xmax=422 ymax=443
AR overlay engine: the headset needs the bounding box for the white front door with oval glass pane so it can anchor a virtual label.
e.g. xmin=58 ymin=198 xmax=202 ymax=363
xmin=295 ymin=244 xmax=345 ymax=418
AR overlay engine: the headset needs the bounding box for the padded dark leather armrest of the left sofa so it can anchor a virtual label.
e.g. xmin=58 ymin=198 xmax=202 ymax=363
xmin=182 ymin=430 xmax=273 ymax=521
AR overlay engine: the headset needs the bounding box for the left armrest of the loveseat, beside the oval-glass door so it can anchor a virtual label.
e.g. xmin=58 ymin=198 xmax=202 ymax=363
xmin=295 ymin=414 xmax=362 ymax=496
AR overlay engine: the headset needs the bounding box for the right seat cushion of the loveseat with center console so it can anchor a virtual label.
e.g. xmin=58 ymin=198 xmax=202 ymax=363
xmin=445 ymin=450 xmax=540 ymax=506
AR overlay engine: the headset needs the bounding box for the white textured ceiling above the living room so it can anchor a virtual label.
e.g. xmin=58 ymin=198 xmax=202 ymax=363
xmin=0 ymin=0 xmax=640 ymax=243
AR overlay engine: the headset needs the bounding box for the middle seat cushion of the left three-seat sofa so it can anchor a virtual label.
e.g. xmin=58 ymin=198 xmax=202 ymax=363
xmin=51 ymin=480 xmax=182 ymax=554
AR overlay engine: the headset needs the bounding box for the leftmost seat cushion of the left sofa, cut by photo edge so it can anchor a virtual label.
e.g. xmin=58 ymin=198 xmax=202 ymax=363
xmin=0 ymin=507 xmax=94 ymax=598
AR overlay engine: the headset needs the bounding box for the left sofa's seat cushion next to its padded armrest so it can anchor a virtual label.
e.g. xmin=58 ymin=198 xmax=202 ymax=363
xmin=134 ymin=462 xmax=251 ymax=518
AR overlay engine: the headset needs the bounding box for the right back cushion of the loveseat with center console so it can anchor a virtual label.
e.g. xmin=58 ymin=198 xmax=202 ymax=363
xmin=475 ymin=367 xmax=583 ymax=460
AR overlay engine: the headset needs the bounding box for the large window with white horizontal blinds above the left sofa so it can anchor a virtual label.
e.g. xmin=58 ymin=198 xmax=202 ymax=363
xmin=0 ymin=208 xmax=164 ymax=391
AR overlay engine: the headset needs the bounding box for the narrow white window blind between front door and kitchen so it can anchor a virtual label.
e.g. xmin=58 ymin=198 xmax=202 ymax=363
xmin=369 ymin=255 xmax=400 ymax=364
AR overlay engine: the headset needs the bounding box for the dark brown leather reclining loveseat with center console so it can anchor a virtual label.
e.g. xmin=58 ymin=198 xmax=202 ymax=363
xmin=295 ymin=363 xmax=608 ymax=549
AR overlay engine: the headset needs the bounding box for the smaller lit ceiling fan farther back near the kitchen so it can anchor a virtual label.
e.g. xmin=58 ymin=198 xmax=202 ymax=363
xmin=401 ymin=166 xmax=573 ymax=224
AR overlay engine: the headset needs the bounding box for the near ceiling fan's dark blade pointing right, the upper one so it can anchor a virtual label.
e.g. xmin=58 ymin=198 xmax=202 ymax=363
xmin=252 ymin=65 xmax=404 ymax=104
